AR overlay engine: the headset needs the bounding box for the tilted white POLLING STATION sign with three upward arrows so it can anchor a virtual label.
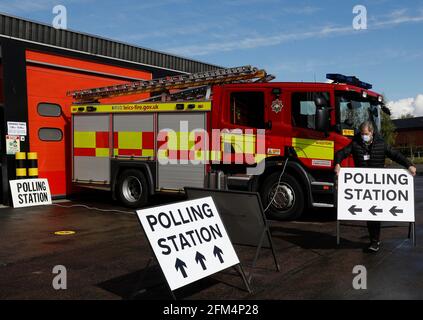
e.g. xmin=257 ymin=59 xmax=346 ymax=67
xmin=137 ymin=197 xmax=239 ymax=291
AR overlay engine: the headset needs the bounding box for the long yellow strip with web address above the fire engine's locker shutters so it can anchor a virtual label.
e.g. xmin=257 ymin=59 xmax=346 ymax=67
xmin=71 ymin=101 xmax=211 ymax=113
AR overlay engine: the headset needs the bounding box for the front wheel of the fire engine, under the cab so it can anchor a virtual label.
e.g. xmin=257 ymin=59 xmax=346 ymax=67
xmin=260 ymin=172 xmax=305 ymax=220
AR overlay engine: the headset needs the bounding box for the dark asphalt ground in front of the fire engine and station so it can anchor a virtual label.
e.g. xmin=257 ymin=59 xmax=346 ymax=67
xmin=0 ymin=177 xmax=423 ymax=300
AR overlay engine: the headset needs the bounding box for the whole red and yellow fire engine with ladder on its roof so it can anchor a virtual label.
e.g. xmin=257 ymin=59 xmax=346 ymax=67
xmin=69 ymin=66 xmax=386 ymax=220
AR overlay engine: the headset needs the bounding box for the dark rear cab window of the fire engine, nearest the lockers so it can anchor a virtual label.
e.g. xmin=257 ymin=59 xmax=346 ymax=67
xmin=230 ymin=92 xmax=264 ymax=129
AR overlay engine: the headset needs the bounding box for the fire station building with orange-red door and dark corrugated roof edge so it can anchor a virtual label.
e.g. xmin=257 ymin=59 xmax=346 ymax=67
xmin=0 ymin=14 xmax=218 ymax=204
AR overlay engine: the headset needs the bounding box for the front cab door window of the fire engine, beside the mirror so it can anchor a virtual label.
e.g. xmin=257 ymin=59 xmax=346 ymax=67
xmin=292 ymin=92 xmax=330 ymax=129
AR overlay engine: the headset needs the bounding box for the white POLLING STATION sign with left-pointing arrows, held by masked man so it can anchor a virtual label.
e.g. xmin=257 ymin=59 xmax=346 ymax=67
xmin=337 ymin=168 xmax=415 ymax=222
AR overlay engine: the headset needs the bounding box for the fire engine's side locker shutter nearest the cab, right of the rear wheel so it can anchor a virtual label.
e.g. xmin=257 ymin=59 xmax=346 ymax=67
xmin=157 ymin=112 xmax=206 ymax=190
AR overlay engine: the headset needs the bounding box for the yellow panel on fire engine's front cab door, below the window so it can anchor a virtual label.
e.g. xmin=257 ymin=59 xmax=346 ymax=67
xmin=292 ymin=138 xmax=335 ymax=160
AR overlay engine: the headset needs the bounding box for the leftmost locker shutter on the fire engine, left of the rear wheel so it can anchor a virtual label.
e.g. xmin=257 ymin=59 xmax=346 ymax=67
xmin=73 ymin=115 xmax=110 ymax=184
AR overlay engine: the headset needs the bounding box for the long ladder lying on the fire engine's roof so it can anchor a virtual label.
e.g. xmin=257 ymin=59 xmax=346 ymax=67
xmin=67 ymin=66 xmax=275 ymax=103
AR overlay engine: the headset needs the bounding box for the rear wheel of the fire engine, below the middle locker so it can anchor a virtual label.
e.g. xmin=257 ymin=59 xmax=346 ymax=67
xmin=117 ymin=169 xmax=148 ymax=208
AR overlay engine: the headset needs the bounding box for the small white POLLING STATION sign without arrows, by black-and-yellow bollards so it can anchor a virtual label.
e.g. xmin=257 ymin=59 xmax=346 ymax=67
xmin=9 ymin=179 xmax=51 ymax=208
